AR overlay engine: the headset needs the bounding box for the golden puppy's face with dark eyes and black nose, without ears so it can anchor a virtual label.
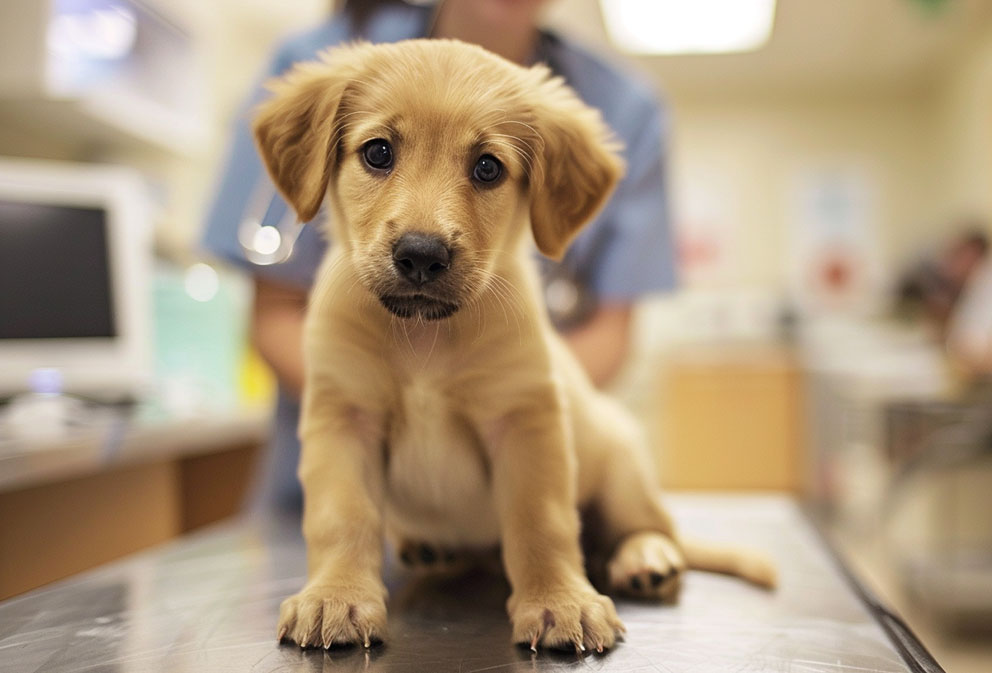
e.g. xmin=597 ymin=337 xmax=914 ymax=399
xmin=331 ymin=59 xmax=536 ymax=319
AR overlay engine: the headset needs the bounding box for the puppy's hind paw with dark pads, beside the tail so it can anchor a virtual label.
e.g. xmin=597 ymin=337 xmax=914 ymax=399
xmin=607 ymin=532 xmax=686 ymax=601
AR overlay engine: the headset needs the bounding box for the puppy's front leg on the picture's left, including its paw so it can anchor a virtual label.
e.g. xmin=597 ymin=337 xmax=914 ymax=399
xmin=278 ymin=395 xmax=386 ymax=647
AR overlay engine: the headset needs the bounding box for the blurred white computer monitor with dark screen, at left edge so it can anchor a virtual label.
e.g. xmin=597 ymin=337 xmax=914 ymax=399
xmin=0 ymin=159 xmax=152 ymax=397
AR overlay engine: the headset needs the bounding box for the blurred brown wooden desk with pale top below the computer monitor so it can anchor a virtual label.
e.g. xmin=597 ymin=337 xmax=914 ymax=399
xmin=0 ymin=417 xmax=267 ymax=599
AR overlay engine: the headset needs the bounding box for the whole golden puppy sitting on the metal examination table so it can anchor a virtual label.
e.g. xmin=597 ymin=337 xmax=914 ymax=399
xmin=254 ymin=40 xmax=774 ymax=651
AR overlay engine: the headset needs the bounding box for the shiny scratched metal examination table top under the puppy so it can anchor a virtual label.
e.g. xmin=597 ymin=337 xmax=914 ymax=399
xmin=0 ymin=495 xmax=939 ymax=673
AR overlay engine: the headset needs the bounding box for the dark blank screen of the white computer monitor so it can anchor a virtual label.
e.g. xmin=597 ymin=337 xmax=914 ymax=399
xmin=0 ymin=198 xmax=117 ymax=339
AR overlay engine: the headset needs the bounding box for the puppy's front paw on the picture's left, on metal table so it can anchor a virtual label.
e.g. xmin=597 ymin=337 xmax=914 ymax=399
xmin=278 ymin=584 xmax=386 ymax=648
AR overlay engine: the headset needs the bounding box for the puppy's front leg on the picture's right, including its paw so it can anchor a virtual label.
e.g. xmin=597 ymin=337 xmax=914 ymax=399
xmin=489 ymin=392 xmax=623 ymax=651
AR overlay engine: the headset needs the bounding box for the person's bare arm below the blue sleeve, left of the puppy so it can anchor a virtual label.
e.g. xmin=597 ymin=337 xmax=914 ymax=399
xmin=251 ymin=276 xmax=307 ymax=397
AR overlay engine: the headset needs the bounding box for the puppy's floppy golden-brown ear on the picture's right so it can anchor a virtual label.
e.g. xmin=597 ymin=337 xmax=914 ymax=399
xmin=530 ymin=66 xmax=624 ymax=259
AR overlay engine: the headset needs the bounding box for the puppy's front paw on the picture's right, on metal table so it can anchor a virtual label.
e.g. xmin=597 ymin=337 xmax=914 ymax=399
xmin=507 ymin=585 xmax=626 ymax=652
